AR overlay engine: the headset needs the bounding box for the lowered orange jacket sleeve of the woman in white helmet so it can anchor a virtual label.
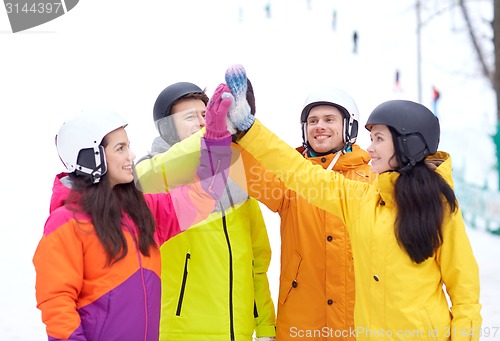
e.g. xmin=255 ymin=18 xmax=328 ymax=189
xmin=33 ymin=211 xmax=86 ymax=341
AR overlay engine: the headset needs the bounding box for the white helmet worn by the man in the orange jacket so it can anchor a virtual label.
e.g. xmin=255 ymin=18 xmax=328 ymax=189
xmin=300 ymin=88 xmax=359 ymax=146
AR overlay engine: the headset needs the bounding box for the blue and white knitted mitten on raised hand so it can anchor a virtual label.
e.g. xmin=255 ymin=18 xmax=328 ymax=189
xmin=222 ymin=64 xmax=255 ymax=134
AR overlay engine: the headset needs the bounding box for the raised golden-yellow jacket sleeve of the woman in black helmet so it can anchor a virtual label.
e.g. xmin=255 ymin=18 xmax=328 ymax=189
xmin=238 ymin=119 xmax=370 ymax=225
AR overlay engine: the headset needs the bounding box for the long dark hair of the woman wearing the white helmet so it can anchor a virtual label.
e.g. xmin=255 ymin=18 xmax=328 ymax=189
xmin=66 ymin=138 xmax=156 ymax=265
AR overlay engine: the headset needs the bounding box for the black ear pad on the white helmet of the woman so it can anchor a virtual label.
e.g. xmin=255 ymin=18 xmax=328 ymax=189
xmin=75 ymin=145 xmax=108 ymax=183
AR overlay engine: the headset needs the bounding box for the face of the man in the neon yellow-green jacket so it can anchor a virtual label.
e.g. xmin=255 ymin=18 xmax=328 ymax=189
xmin=171 ymin=98 xmax=206 ymax=141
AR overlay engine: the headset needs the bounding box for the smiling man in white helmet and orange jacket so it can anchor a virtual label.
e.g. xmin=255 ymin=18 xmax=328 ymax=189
xmin=237 ymin=88 xmax=371 ymax=340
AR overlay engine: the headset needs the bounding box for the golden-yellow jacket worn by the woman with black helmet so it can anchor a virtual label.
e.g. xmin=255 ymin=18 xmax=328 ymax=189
xmin=239 ymin=121 xmax=481 ymax=340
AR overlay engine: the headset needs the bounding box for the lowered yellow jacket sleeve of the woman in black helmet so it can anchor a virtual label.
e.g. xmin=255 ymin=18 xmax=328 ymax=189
xmin=437 ymin=209 xmax=482 ymax=341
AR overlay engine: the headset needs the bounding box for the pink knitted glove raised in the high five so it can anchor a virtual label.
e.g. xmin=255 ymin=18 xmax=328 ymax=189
xmin=204 ymin=83 xmax=232 ymax=140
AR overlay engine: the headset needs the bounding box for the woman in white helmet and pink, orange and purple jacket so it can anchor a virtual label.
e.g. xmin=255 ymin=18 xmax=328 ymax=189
xmin=33 ymin=84 xmax=231 ymax=341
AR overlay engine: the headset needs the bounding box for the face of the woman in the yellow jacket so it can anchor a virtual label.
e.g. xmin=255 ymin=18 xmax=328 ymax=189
xmin=367 ymin=124 xmax=398 ymax=174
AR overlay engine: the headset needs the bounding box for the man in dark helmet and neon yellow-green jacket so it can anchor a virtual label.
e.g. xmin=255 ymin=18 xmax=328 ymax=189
xmin=136 ymin=82 xmax=276 ymax=341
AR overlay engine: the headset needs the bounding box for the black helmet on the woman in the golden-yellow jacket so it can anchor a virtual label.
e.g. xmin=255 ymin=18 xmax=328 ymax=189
xmin=365 ymin=100 xmax=440 ymax=168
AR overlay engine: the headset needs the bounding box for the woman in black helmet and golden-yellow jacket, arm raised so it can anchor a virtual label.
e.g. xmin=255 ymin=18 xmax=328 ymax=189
xmin=226 ymin=66 xmax=481 ymax=341
